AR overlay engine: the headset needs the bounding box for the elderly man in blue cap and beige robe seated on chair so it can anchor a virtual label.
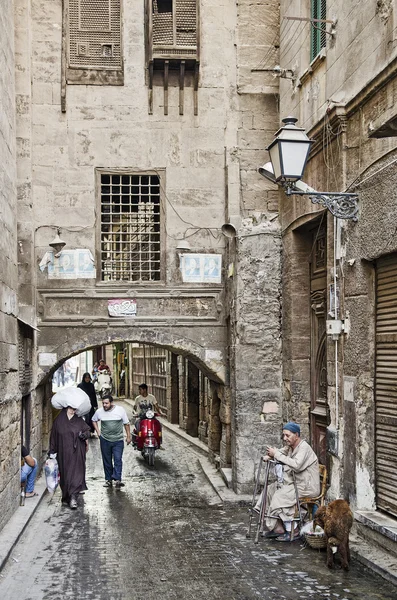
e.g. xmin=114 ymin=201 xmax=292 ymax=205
xmin=255 ymin=422 xmax=320 ymax=542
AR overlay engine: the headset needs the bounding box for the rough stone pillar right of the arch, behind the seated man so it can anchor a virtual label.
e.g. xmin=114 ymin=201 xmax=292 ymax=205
xmin=230 ymin=217 xmax=282 ymax=493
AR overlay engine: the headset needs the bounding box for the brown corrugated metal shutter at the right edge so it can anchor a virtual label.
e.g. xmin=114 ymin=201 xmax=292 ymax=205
xmin=375 ymin=254 xmax=397 ymax=516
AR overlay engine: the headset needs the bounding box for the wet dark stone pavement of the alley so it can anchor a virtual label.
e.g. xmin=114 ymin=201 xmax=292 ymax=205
xmin=0 ymin=400 xmax=397 ymax=600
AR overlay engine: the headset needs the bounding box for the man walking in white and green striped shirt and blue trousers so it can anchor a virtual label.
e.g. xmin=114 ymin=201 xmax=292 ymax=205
xmin=92 ymin=395 xmax=131 ymax=488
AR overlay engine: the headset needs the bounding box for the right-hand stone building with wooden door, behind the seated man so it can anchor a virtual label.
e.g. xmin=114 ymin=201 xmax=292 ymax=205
xmin=276 ymin=0 xmax=397 ymax=544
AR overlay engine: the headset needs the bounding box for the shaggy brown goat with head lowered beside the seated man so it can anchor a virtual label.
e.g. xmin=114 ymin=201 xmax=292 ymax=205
xmin=314 ymin=500 xmax=353 ymax=571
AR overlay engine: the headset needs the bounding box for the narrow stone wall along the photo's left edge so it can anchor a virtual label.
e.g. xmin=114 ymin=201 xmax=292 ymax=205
xmin=0 ymin=2 xmax=21 ymax=529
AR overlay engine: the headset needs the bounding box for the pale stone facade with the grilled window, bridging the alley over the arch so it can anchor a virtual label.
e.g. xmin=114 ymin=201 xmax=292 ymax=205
xmin=0 ymin=0 xmax=281 ymax=526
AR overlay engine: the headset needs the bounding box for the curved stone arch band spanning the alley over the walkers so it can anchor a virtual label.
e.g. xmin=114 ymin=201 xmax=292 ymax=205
xmin=37 ymin=325 xmax=225 ymax=385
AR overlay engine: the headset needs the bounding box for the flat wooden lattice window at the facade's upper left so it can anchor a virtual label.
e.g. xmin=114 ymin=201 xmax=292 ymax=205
xmin=67 ymin=0 xmax=123 ymax=83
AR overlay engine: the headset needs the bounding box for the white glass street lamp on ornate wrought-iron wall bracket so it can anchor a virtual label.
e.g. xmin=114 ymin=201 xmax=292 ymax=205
xmin=258 ymin=117 xmax=358 ymax=221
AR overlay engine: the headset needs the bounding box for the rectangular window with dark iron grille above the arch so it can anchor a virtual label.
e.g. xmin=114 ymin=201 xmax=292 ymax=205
xmin=100 ymin=173 xmax=161 ymax=282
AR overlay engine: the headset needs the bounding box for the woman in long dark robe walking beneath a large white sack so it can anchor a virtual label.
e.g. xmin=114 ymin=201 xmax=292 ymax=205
xmin=49 ymin=406 xmax=90 ymax=508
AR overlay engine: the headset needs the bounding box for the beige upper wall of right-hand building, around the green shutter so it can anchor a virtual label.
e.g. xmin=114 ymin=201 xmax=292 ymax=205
xmin=272 ymin=0 xmax=397 ymax=129
